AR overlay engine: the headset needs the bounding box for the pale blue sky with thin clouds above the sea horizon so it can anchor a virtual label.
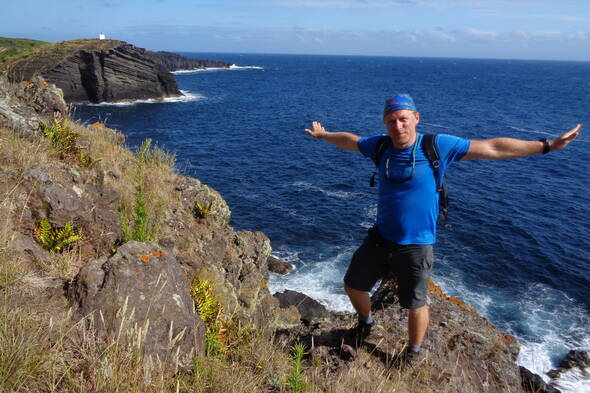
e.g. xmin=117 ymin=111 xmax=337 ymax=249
xmin=0 ymin=0 xmax=590 ymax=61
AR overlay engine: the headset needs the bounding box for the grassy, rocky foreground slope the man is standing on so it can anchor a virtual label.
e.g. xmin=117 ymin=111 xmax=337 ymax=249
xmin=0 ymin=79 xmax=572 ymax=393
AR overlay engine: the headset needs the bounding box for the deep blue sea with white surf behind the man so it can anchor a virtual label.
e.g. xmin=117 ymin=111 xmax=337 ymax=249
xmin=75 ymin=53 xmax=590 ymax=392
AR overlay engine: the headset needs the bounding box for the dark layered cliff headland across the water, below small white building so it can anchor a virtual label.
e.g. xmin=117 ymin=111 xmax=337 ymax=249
xmin=5 ymin=40 xmax=181 ymax=103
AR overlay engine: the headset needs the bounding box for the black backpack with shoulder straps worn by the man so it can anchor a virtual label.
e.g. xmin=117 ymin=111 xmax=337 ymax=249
xmin=369 ymin=134 xmax=449 ymax=220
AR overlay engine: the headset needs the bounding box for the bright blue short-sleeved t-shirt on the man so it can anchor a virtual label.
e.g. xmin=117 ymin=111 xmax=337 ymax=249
xmin=358 ymin=133 xmax=470 ymax=244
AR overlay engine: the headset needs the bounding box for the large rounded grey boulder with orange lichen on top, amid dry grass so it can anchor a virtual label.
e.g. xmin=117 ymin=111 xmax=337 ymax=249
xmin=71 ymin=242 xmax=205 ymax=367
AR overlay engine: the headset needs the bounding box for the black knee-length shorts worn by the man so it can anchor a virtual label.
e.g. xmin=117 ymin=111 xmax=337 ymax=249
xmin=344 ymin=229 xmax=434 ymax=309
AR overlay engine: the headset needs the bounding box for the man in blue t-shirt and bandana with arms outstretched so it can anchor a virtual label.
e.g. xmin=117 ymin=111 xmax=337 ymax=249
xmin=305 ymin=94 xmax=581 ymax=364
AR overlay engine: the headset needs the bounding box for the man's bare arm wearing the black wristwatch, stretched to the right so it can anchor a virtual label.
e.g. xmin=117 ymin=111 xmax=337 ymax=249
xmin=463 ymin=124 xmax=582 ymax=160
